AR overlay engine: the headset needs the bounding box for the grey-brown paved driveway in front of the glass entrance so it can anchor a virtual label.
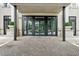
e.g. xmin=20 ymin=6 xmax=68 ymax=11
xmin=0 ymin=36 xmax=79 ymax=56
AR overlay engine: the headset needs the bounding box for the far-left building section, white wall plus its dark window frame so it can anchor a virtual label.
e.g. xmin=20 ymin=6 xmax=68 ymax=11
xmin=0 ymin=4 xmax=11 ymax=34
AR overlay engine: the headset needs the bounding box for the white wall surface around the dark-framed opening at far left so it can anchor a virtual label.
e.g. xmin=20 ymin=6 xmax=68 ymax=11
xmin=0 ymin=4 xmax=11 ymax=32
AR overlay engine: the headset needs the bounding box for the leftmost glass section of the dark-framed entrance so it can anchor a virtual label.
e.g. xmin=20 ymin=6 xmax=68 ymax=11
xmin=22 ymin=16 xmax=32 ymax=35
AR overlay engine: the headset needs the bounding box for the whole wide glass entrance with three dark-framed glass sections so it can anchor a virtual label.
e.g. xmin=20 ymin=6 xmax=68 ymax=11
xmin=22 ymin=16 xmax=57 ymax=36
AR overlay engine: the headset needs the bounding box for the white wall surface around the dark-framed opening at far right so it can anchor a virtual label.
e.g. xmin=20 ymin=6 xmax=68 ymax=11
xmin=66 ymin=5 xmax=79 ymax=30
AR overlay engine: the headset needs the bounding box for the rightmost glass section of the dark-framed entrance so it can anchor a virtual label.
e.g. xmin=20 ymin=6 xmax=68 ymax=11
xmin=48 ymin=17 xmax=56 ymax=35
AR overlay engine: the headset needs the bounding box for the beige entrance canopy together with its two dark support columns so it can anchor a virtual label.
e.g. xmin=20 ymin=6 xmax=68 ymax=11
xmin=12 ymin=3 xmax=70 ymax=41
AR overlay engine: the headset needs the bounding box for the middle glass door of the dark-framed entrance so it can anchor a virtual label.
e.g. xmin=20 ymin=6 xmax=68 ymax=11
xmin=35 ymin=17 xmax=45 ymax=35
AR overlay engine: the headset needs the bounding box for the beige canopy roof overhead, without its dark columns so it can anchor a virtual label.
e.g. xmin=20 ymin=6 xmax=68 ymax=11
xmin=12 ymin=3 xmax=69 ymax=14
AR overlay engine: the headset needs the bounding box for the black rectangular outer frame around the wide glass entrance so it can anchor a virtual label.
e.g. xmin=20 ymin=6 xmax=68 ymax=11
xmin=22 ymin=15 xmax=58 ymax=36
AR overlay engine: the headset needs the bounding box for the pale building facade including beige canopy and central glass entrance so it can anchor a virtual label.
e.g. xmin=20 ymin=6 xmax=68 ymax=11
xmin=0 ymin=3 xmax=79 ymax=40
